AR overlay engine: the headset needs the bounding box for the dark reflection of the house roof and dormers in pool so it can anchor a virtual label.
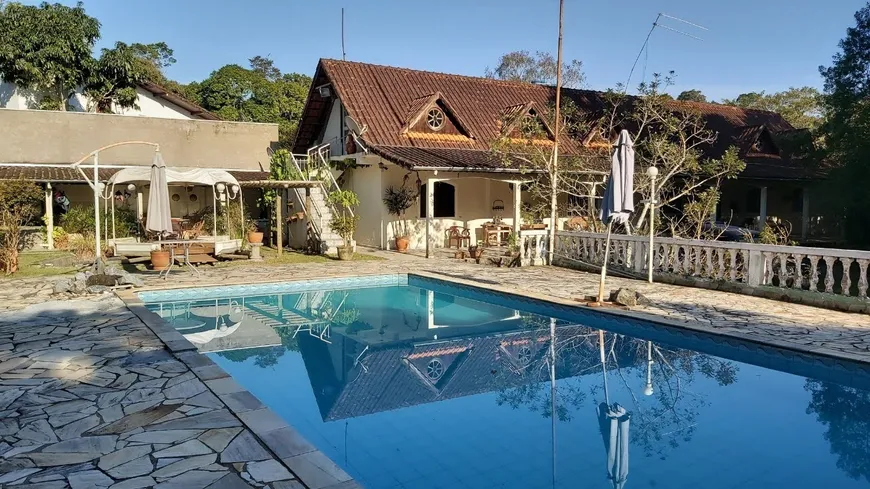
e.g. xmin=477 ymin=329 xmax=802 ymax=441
xmin=299 ymin=325 xmax=636 ymax=421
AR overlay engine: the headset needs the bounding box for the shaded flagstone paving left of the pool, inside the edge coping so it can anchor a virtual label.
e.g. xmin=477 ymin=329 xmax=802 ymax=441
xmin=0 ymin=298 xmax=304 ymax=489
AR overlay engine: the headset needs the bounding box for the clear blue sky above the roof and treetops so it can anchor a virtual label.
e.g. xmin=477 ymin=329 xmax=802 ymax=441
xmin=25 ymin=0 xmax=865 ymax=100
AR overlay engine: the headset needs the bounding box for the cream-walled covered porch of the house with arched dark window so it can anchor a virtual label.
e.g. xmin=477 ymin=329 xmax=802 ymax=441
xmin=339 ymin=154 xmax=604 ymax=254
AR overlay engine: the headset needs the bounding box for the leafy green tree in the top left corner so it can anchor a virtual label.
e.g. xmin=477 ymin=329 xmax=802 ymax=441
xmin=0 ymin=2 xmax=100 ymax=110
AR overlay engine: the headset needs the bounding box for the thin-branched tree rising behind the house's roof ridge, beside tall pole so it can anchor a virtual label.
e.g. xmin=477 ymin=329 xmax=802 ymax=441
xmin=485 ymin=51 xmax=585 ymax=88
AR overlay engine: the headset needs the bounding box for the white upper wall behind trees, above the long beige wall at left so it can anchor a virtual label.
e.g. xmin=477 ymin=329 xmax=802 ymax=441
xmin=0 ymin=80 xmax=196 ymax=119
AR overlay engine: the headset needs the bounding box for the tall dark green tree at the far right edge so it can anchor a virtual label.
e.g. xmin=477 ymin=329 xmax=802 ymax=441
xmin=819 ymin=3 xmax=870 ymax=246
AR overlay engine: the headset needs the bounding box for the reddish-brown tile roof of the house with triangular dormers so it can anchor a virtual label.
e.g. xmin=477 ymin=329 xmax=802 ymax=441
xmin=294 ymin=59 xmax=816 ymax=178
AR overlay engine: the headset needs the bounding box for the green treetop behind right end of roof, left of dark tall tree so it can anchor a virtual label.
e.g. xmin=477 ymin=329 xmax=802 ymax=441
xmin=722 ymin=87 xmax=824 ymax=130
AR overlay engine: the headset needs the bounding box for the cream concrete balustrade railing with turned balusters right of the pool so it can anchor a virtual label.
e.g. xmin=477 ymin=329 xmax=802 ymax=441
xmin=552 ymin=231 xmax=870 ymax=299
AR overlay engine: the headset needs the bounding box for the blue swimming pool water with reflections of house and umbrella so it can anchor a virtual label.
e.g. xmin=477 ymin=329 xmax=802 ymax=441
xmin=142 ymin=276 xmax=870 ymax=489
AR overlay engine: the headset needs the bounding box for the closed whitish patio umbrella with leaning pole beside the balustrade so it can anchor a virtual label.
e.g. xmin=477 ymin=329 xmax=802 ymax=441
xmin=598 ymin=129 xmax=634 ymax=302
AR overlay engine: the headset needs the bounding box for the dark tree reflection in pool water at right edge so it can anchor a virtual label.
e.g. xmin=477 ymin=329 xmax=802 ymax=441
xmin=804 ymin=379 xmax=870 ymax=481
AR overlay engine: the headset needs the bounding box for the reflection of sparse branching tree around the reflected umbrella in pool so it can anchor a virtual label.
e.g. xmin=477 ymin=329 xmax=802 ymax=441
xmin=494 ymin=317 xmax=738 ymax=458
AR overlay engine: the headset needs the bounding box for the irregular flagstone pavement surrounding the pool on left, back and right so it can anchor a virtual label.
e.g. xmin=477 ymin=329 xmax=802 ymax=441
xmin=0 ymin=252 xmax=870 ymax=489
